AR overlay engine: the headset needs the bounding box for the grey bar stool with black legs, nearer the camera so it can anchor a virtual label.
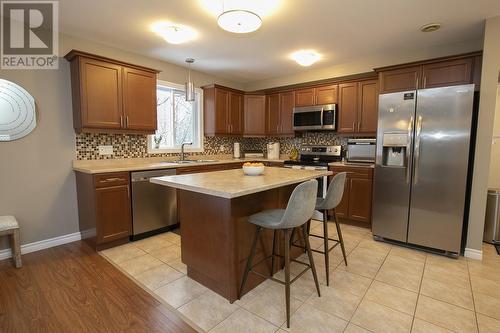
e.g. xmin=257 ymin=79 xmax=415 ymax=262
xmin=238 ymin=179 xmax=321 ymax=328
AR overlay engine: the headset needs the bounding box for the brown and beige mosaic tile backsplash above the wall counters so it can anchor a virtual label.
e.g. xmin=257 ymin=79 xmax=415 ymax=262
xmin=76 ymin=132 xmax=347 ymax=160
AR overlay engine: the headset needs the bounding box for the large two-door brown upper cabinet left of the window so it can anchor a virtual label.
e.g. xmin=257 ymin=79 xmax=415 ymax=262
xmin=65 ymin=50 xmax=158 ymax=133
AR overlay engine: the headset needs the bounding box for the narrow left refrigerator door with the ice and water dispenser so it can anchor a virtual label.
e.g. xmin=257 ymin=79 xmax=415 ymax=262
xmin=372 ymin=91 xmax=417 ymax=242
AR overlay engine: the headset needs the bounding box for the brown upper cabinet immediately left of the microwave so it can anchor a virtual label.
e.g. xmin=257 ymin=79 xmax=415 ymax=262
xmin=266 ymin=91 xmax=296 ymax=136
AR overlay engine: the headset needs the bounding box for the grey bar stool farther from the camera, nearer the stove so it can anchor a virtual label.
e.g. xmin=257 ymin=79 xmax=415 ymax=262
xmin=291 ymin=172 xmax=347 ymax=286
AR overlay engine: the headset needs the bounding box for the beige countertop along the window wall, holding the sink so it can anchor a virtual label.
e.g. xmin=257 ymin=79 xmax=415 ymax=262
xmin=73 ymin=155 xmax=285 ymax=174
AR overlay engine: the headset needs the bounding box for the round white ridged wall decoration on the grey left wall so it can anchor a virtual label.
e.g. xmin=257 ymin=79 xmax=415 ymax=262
xmin=0 ymin=79 xmax=36 ymax=141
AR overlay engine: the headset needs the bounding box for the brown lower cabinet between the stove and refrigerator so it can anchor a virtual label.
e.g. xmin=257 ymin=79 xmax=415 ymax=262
xmin=330 ymin=166 xmax=373 ymax=224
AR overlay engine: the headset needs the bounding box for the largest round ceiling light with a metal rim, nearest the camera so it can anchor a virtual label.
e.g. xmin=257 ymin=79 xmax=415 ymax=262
xmin=217 ymin=9 xmax=262 ymax=34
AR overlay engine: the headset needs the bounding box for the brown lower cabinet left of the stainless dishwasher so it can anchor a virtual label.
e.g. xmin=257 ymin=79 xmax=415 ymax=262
xmin=76 ymin=172 xmax=132 ymax=250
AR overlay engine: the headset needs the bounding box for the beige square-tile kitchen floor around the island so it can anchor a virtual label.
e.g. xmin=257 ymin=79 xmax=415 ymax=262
xmin=101 ymin=221 xmax=500 ymax=333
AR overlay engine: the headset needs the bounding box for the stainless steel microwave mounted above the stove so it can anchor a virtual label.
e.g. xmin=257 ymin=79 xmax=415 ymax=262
xmin=293 ymin=104 xmax=337 ymax=131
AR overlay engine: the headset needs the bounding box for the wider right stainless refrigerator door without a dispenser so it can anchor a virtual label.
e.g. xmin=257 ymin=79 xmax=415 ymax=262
xmin=408 ymin=85 xmax=474 ymax=253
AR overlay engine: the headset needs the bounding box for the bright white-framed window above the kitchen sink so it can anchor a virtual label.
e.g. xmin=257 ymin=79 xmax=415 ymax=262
xmin=148 ymin=81 xmax=203 ymax=154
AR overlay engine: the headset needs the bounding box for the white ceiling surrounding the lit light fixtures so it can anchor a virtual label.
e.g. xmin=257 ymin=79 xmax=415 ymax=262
xmin=59 ymin=0 xmax=500 ymax=83
